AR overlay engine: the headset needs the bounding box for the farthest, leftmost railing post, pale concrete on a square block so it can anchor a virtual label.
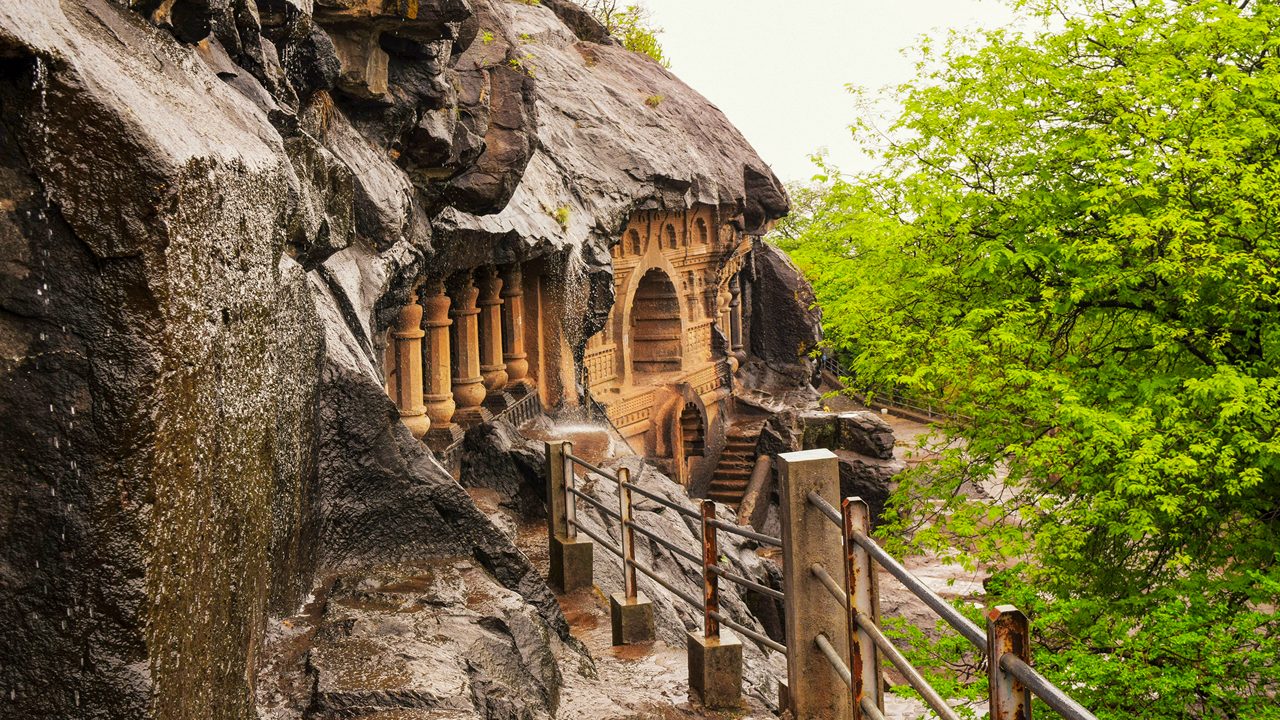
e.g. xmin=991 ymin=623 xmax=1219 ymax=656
xmin=547 ymin=441 xmax=593 ymax=592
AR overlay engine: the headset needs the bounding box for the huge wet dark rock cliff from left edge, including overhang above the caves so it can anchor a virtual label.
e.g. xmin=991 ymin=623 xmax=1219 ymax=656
xmin=0 ymin=0 xmax=787 ymax=719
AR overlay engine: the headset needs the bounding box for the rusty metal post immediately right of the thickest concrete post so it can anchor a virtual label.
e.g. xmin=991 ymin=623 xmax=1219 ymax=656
xmin=841 ymin=497 xmax=884 ymax=720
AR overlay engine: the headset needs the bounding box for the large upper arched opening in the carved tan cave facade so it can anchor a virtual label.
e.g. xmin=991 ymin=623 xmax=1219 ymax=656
xmin=631 ymin=268 xmax=685 ymax=375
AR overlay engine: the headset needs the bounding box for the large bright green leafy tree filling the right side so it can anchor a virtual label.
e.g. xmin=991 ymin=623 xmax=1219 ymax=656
xmin=776 ymin=0 xmax=1280 ymax=719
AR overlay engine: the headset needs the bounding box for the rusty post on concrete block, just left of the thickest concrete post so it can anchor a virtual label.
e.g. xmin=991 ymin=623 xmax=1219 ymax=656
xmin=689 ymin=500 xmax=742 ymax=708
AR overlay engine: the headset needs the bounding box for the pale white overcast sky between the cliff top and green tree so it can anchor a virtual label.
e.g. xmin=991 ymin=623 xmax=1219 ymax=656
xmin=644 ymin=0 xmax=1012 ymax=181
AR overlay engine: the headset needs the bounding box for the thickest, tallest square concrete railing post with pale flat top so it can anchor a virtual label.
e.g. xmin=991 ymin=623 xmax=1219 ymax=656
xmin=778 ymin=450 xmax=852 ymax=720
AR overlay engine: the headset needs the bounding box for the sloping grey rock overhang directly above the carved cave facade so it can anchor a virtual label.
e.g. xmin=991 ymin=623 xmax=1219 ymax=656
xmin=424 ymin=0 xmax=790 ymax=255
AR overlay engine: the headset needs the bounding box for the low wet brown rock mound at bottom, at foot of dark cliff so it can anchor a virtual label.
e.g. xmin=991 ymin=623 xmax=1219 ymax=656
xmin=259 ymin=556 xmax=573 ymax=720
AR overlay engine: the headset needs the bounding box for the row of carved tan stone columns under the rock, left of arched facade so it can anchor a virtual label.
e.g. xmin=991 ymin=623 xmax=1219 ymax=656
xmin=388 ymin=260 xmax=530 ymax=448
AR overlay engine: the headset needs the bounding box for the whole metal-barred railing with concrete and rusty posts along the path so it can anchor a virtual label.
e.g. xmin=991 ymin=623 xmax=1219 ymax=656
xmin=547 ymin=441 xmax=1096 ymax=720
